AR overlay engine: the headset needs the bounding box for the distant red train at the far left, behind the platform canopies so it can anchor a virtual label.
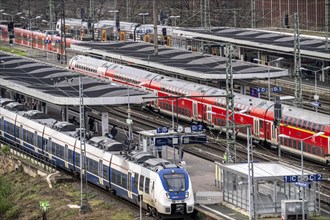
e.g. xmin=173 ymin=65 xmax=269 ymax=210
xmin=0 ymin=25 xmax=78 ymax=53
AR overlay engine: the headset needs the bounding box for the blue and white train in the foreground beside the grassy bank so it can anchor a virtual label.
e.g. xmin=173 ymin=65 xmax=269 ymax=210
xmin=0 ymin=104 xmax=194 ymax=218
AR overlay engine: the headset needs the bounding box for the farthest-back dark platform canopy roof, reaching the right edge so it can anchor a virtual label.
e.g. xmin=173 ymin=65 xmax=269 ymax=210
xmin=173 ymin=27 xmax=330 ymax=60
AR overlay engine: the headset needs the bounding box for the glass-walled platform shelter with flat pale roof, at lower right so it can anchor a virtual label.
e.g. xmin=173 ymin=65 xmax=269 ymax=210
xmin=215 ymin=162 xmax=322 ymax=218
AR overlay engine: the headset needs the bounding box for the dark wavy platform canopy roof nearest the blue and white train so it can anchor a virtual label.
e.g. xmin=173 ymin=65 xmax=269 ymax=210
xmin=0 ymin=53 xmax=151 ymax=107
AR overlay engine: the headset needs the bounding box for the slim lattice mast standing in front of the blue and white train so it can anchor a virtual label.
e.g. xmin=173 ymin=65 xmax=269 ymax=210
xmin=79 ymin=76 xmax=91 ymax=214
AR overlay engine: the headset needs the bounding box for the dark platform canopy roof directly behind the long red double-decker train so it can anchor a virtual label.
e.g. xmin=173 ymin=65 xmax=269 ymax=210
xmin=72 ymin=42 xmax=288 ymax=80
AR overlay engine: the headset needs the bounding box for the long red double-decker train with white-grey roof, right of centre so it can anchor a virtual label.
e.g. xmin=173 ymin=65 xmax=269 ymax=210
xmin=68 ymin=56 xmax=330 ymax=163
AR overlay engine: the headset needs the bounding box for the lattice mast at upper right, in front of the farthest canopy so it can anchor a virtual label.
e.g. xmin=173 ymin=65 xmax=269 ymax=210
xmin=294 ymin=13 xmax=302 ymax=107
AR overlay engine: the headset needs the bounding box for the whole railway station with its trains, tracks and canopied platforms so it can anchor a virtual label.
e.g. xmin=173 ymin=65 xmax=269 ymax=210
xmin=0 ymin=0 xmax=330 ymax=220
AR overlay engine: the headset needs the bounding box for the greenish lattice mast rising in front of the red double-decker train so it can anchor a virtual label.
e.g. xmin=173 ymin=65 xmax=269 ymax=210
xmin=226 ymin=44 xmax=236 ymax=163
